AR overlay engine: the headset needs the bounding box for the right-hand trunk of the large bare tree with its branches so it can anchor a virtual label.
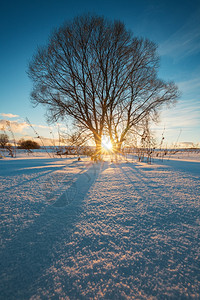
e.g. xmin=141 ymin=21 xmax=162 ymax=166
xmin=106 ymin=38 xmax=179 ymax=151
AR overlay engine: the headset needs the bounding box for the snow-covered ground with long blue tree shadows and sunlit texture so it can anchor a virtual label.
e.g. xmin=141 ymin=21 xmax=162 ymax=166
xmin=0 ymin=153 xmax=200 ymax=300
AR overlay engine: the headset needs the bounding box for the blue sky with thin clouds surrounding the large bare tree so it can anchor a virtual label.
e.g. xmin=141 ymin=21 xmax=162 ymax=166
xmin=0 ymin=0 xmax=200 ymax=145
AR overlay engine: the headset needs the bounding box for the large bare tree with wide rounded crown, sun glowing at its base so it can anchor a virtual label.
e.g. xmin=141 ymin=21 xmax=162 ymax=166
xmin=28 ymin=15 xmax=178 ymax=152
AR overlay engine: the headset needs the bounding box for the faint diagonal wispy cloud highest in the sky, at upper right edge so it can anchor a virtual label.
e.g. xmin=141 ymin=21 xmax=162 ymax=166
xmin=159 ymin=10 xmax=200 ymax=60
